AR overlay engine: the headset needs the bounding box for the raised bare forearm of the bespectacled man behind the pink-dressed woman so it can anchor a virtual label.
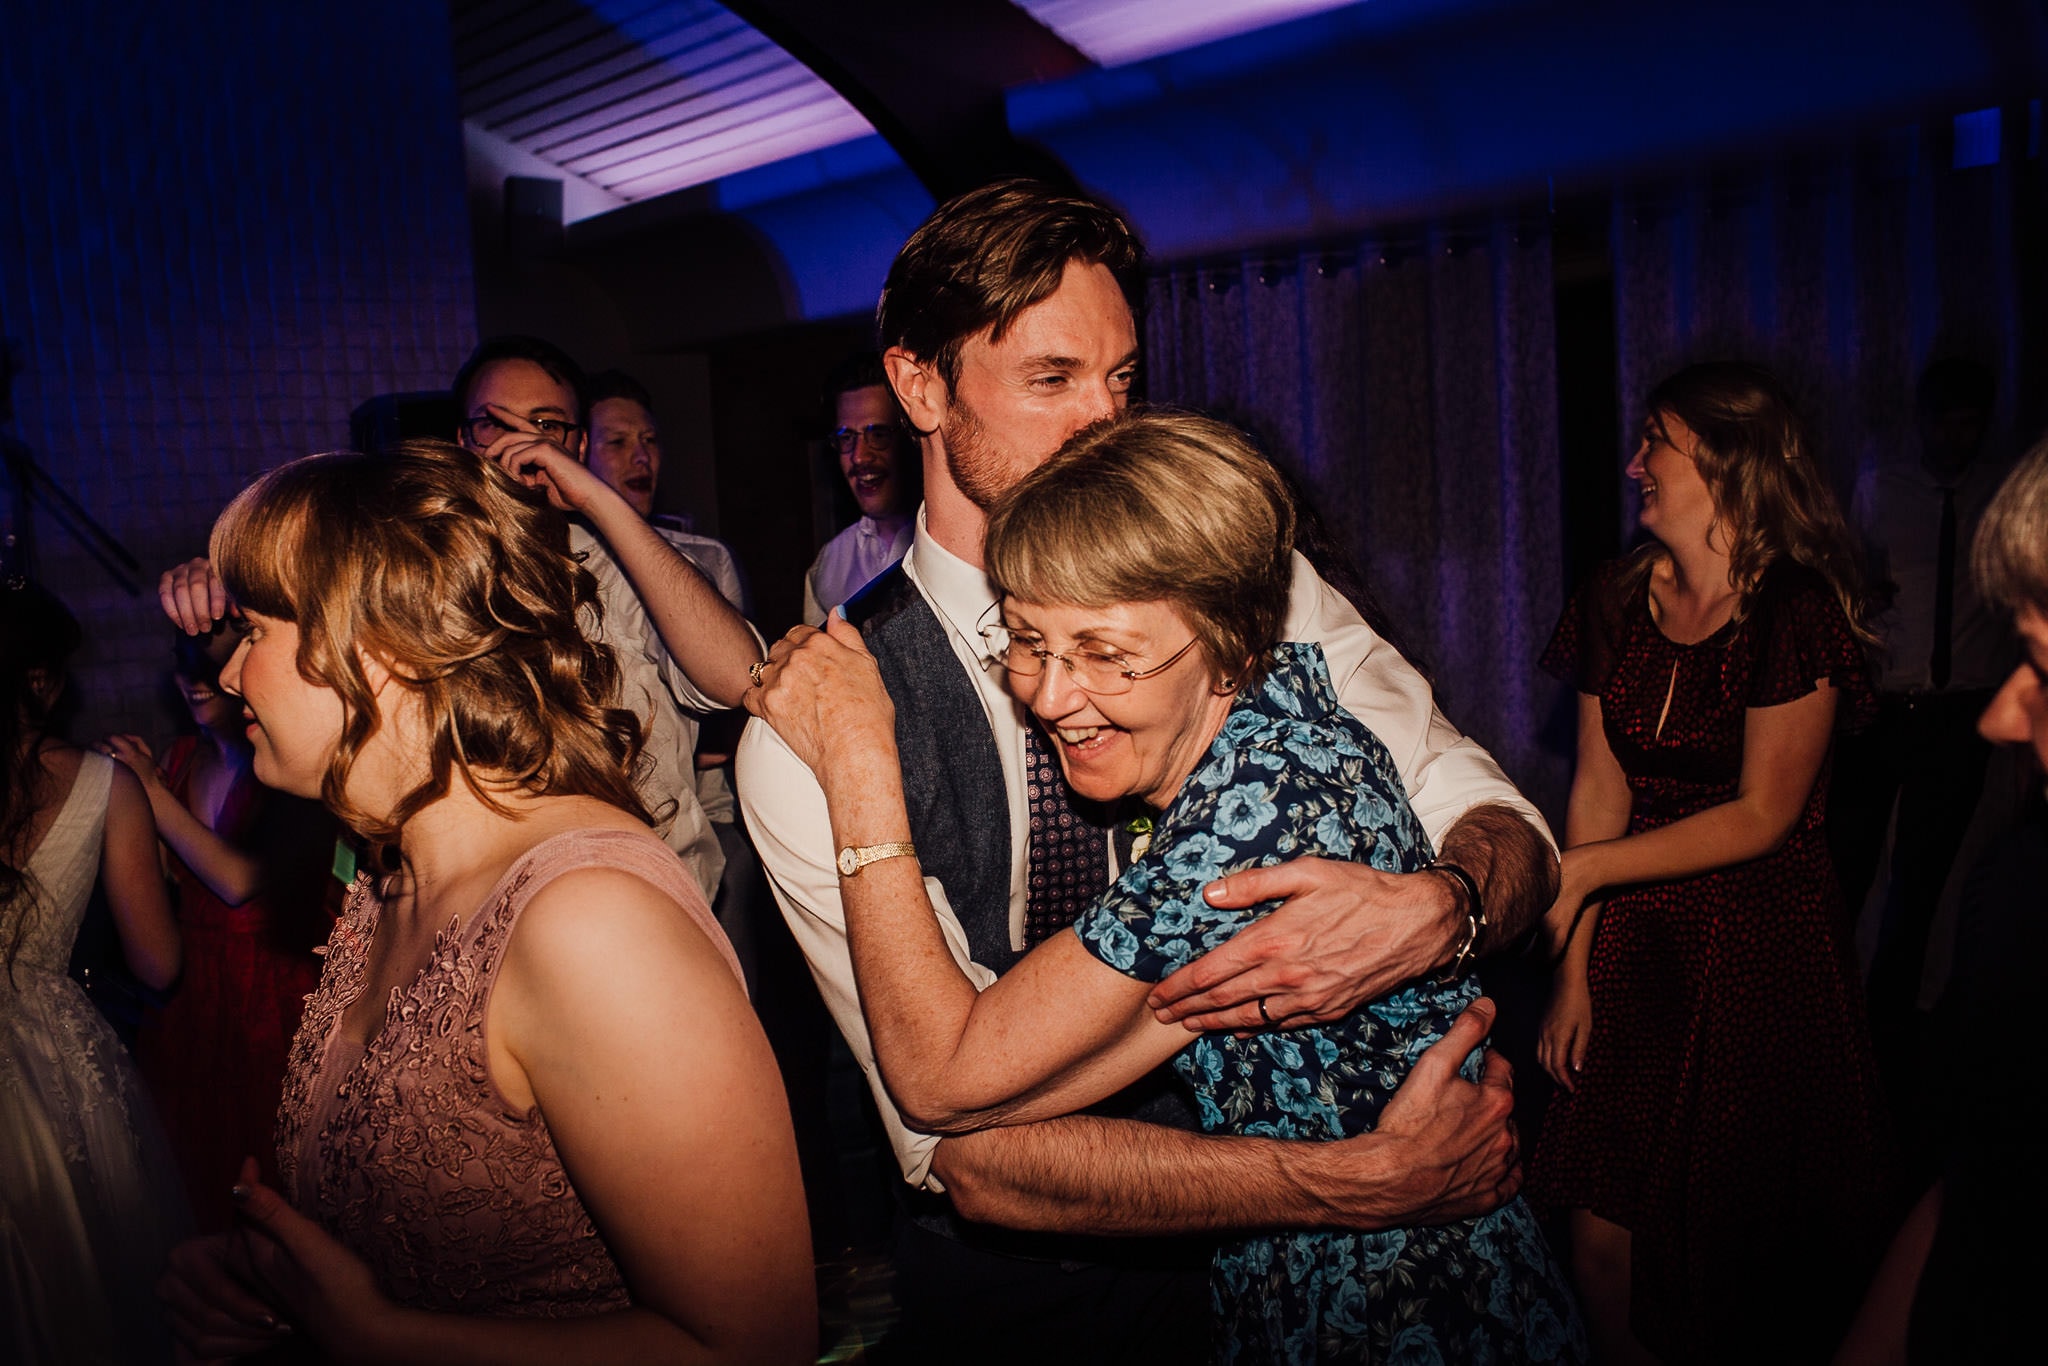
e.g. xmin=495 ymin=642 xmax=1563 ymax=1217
xmin=586 ymin=500 xmax=762 ymax=707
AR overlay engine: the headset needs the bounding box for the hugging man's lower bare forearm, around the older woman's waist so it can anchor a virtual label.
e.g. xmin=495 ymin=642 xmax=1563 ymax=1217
xmin=932 ymin=1114 xmax=1430 ymax=1237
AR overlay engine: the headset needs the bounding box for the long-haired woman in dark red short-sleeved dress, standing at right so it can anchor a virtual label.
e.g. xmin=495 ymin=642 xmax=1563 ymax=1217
xmin=1530 ymin=365 xmax=1888 ymax=1362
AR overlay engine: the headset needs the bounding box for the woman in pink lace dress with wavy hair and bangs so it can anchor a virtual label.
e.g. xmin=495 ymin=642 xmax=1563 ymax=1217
xmin=166 ymin=442 xmax=815 ymax=1362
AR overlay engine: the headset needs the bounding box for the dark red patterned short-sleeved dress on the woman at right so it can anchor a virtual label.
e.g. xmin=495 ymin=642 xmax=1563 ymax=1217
xmin=1528 ymin=561 xmax=1896 ymax=1362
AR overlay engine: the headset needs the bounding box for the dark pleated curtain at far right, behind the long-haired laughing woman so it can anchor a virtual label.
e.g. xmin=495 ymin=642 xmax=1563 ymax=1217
xmin=1610 ymin=118 xmax=2048 ymax=520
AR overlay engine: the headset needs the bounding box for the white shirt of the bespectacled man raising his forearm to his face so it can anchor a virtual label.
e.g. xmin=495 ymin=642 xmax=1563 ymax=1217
xmin=569 ymin=518 xmax=761 ymax=901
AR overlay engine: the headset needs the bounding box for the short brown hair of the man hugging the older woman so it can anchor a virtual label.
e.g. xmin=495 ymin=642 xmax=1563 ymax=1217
xmin=874 ymin=178 xmax=1145 ymax=385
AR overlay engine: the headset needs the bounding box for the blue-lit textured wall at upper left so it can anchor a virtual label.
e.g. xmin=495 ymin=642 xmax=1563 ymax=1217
xmin=0 ymin=0 xmax=475 ymax=739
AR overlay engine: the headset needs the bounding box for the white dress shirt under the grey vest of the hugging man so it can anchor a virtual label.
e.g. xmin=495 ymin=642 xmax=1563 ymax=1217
xmin=739 ymin=510 xmax=1554 ymax=1190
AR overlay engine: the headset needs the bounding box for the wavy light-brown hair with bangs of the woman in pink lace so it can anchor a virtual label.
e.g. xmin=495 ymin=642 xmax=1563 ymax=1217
xmin=211 ymin=440 xmax=647 ymax=842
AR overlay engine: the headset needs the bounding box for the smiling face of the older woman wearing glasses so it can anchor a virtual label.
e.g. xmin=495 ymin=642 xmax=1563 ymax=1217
xmin=1004 ymin=598 xmax=1233 ymax=809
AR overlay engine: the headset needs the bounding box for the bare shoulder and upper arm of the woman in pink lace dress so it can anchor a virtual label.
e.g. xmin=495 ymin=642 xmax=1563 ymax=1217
xmin=485 ymin=868 xmax=817 ymax=1360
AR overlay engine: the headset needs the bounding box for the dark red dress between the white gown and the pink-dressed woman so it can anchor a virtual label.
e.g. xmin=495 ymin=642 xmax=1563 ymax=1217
xmin=135 ymin=735 xmax=328 ymax=1231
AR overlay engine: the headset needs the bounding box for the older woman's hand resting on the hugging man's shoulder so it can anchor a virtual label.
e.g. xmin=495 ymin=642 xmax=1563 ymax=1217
xmin=743 ymin=612 xmax=895 ymax=782
